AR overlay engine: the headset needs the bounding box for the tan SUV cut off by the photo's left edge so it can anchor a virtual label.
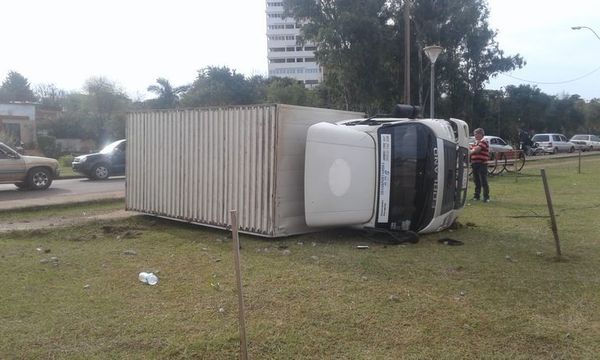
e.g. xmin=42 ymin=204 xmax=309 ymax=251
xmin=0 ymin=142 xmax=60 ymax=190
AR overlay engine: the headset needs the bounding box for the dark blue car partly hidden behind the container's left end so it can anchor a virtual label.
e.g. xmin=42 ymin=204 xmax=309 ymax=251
xmin=71 ymin=139 xmax=127 ymax=180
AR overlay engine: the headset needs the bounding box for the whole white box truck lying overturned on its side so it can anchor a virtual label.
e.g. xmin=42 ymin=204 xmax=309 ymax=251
xmin=126 ymin=104 xmax=469 ymax=237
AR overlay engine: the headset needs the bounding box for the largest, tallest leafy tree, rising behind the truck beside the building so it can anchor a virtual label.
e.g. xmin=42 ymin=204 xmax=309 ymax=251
xmin=284 ymin=0 xmax=523 ymax=120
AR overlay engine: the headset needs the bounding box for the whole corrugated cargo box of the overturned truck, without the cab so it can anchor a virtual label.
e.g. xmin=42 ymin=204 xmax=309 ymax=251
xmin=126 ymin=104 xmax=364 ymax=237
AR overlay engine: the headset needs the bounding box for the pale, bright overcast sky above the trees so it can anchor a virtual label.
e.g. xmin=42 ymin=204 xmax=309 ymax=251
xmin=0 ymin=0 xmax=600 ymax=100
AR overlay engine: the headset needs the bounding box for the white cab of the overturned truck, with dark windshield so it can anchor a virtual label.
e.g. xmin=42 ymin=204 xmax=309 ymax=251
xmin=304 ymin=112 xmax=469 ymax=233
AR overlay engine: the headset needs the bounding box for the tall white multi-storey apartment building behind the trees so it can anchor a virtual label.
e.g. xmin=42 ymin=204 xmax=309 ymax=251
xmin=266 ymin=0 xmax=323 ymax=87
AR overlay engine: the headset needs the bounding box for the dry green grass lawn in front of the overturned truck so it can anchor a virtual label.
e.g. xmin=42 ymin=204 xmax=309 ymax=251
xmin=0 ymin=156 xmax=600 ymax=359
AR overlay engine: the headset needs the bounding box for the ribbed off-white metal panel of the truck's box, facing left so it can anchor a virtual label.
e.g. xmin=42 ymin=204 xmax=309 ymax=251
xmin=126 ymin=105 xmax=277 ymax=236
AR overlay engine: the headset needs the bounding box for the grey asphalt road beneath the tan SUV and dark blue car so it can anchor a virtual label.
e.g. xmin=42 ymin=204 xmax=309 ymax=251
xmin=0 ymin=177 xmax=125 ymax=210
